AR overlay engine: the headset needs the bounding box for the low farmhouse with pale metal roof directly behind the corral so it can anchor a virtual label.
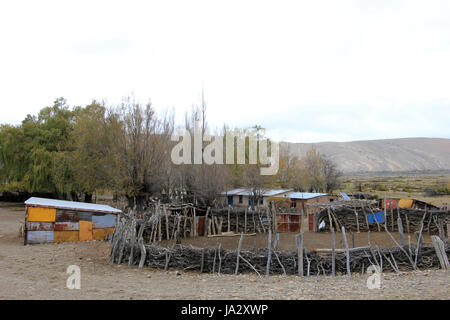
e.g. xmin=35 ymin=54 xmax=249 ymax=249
xmin=221 ymin=189 xmax=291 ymax=207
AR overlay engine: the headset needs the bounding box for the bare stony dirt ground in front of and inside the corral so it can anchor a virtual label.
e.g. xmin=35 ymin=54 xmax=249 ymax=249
xmin=0 ymin=203 xmax=450 ymax=300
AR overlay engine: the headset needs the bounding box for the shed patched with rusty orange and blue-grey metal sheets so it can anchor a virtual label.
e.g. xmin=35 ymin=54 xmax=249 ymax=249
xmin=25 ymin=197 xmax=121 ymax=244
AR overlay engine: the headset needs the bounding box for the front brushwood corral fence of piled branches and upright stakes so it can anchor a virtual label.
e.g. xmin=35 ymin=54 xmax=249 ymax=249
xmin=110 ymin=212 xmax=450 ymax=276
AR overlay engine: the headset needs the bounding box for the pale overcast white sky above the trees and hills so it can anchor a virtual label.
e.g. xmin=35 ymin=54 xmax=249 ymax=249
xmin=0 ymin=0 xmax=450 ymax=142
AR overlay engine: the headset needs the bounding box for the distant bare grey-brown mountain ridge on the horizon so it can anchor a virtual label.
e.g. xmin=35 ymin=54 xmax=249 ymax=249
xmin=281 ymin=138 xmax=450 ymax=173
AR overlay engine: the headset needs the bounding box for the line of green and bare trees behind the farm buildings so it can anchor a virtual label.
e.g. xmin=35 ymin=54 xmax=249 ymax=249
xmin=0 ymin=97 xmax=341 ymax=206
